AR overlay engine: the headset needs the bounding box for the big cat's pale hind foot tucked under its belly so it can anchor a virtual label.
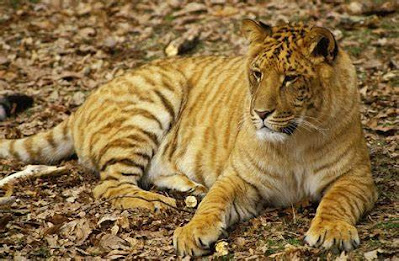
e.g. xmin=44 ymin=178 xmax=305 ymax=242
xmin=152 ymin=173 xmax=208 ymax=197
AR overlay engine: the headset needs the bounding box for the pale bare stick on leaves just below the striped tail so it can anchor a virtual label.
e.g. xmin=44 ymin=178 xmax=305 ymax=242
xmin=0 ymin=165 xmax=66 ymax=188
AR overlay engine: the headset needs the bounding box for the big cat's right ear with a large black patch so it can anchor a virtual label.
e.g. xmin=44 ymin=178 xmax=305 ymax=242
xmin=305 ymin=27 xmax=338 ymax=63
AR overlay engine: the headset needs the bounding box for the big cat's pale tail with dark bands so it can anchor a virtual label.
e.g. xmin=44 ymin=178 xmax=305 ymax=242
xmin=0 ymin=118 xmax=74 ymax=163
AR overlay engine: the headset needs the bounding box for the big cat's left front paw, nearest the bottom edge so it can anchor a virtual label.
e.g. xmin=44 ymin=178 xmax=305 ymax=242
xmin=173 ymin=219 xmax=223 ymax=256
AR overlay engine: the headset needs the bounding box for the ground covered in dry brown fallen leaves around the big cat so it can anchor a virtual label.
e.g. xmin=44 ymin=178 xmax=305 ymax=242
xmin=0 ymin=0 xmax=399 ymax=260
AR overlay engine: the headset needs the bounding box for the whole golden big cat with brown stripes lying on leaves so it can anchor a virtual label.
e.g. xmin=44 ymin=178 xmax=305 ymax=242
xmin=0 ymin=20 xmax=376 ymax=255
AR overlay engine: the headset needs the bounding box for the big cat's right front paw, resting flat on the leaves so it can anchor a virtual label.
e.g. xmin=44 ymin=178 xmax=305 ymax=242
xmin=305 ymin=217 xmax=360 ymax=251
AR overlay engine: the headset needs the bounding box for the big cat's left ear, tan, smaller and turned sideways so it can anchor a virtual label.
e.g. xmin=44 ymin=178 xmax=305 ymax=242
xmin=241 ymin=19 xmax=272 ymax=44
